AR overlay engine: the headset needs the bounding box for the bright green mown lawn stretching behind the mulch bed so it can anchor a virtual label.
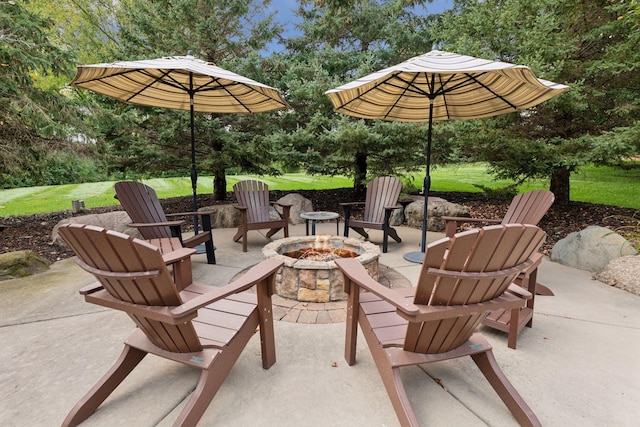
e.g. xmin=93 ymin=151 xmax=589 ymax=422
xmin=0 ymin=164 xmax=640 ymax=216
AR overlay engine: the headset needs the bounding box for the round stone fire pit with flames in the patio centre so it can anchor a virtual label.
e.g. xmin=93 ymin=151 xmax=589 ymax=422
xmin=262 ymin=236 xmax=380 ymax=302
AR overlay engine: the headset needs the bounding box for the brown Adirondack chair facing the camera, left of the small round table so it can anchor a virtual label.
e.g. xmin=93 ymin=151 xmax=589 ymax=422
xmin=233 ymin=179 xmax=291 ymax=252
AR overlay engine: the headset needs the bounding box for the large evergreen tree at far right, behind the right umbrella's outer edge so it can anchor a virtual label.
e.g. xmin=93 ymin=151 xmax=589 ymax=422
xmin=428 ymin=0 xmax=640 ymax=202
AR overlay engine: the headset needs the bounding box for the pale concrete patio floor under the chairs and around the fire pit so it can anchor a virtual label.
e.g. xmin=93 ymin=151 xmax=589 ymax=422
xmin=0 ymin=223 xmax=640 ymax=427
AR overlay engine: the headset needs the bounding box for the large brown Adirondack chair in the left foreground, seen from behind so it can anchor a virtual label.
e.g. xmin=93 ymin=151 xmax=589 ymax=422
xmin=59 ymin=224 xmax=281 ymax=426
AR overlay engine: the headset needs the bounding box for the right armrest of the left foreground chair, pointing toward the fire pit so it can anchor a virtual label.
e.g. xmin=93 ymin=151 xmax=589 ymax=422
xmin=171 ymin=258 xmax=283 ymax=316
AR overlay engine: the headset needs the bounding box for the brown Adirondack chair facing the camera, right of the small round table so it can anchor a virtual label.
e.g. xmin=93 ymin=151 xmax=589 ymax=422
xmin=340 ymin=176 xmax=402 ymax=252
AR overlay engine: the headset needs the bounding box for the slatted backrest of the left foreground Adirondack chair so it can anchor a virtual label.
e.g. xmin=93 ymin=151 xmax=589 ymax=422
xmin=59 ymin=224 xmax=202 ymax=353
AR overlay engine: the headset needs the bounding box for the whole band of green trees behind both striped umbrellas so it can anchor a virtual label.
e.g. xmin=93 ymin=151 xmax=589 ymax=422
xmin=0 ymin=0 xmax=640 ymax=211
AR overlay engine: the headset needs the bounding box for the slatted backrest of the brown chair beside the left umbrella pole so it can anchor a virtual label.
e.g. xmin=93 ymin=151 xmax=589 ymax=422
xmin=113 ymin=181 xmax=171 ymax=239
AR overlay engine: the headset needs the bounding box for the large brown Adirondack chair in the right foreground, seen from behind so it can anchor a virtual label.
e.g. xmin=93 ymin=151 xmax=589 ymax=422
xmin=336 ymin=224 xmax=545 ymax=426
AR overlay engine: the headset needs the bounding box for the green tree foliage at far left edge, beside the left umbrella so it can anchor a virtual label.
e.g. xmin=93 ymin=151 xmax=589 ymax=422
xmin=0 ymin=1 xmax=85 ymax=182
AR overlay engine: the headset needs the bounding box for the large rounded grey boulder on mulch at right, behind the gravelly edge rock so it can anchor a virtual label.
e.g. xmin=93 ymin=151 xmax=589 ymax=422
xmin=551 ymin=226 xmax=638 ymax=272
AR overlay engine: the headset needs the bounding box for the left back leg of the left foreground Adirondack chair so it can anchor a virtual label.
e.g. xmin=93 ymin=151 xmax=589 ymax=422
xmin=62 ymin=345 xmax=147 ymax=426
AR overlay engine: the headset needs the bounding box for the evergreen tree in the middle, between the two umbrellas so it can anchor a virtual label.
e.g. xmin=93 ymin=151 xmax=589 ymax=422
xmin=272 ymin=0 xmax=438 ymax=188
